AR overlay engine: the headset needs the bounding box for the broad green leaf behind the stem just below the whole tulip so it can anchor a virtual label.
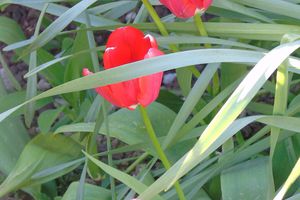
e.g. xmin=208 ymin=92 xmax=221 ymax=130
xmin=55 ymin=103 xmax=195 ymax=161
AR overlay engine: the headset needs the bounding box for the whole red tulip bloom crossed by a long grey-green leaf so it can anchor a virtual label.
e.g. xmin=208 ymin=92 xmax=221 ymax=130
xmin=82 ymin=26 xmax=163 ymax=110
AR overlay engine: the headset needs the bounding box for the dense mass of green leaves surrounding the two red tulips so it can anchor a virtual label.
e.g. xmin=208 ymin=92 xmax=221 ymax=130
xmin=0 ymin=0 xmax=300 ymax=200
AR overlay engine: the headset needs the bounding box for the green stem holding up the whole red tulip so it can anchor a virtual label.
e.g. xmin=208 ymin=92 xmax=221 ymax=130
xmin=140 ymin=105 xmax=185 ymax=200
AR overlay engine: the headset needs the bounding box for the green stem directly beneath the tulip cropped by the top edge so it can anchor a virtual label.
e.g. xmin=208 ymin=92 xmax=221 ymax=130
xmin=194 ymin=12 xmax=220 ymax=96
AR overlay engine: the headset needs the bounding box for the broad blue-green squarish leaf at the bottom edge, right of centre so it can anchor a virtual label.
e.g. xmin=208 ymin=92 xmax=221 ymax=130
xmin=221 ymin=157 xmax=274 ymax=200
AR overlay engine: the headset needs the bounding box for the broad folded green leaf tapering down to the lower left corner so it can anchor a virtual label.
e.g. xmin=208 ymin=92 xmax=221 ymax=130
xmin=0 ymin=134 xmax=81 ymax=197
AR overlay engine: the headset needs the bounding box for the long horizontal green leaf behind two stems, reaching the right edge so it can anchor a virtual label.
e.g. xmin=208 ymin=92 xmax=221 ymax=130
xmin=65 ymin=22 xmax=300 ymax=41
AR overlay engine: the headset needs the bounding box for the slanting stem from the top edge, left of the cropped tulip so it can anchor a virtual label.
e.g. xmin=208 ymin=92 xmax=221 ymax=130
xmin=142 ymin=0 xmax=200 ymax=78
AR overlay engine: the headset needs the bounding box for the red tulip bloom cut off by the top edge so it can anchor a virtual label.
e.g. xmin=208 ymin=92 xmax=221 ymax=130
xmin=160 ymin=0 xmax=213 ymax=18
